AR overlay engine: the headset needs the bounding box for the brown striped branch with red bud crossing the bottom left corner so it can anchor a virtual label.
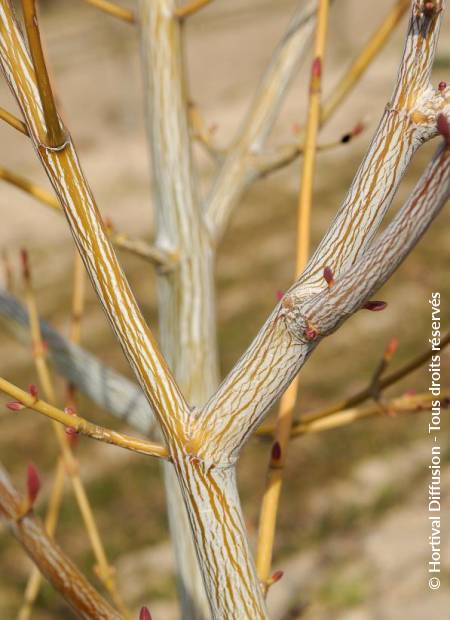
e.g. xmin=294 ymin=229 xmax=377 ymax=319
xmin=0 ymin=465 xmax=123 ymax=620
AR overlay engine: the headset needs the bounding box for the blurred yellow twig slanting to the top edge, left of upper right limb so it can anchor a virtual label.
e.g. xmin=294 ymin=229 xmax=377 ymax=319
xmin=320 ymin=0 xmax=410 ymax=125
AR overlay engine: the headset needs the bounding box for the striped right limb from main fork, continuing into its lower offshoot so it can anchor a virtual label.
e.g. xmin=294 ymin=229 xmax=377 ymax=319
xmin=196 ymin=130 xmax=450 ymax=462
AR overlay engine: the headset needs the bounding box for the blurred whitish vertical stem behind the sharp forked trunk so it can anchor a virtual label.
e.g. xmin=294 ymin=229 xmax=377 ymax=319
xmin=140 ymin=0 xmax=218 ymax=620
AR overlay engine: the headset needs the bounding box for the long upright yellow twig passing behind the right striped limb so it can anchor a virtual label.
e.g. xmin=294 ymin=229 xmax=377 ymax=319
xmin=256 ymin=0 xmax=329 ymax=584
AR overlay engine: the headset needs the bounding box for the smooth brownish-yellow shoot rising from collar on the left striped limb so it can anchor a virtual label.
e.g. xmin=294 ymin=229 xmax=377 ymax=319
xmin=22 ymin=0 xmax=66 ymax=148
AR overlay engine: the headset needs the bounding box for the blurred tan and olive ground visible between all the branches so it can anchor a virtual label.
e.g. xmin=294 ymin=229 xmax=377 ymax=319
xmin=0 ymin=0 xmax=450 ymax=620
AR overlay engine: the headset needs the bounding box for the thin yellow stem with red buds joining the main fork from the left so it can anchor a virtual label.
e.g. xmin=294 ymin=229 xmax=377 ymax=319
xmin=0 ymin=377 xmax=168 ymax=459
